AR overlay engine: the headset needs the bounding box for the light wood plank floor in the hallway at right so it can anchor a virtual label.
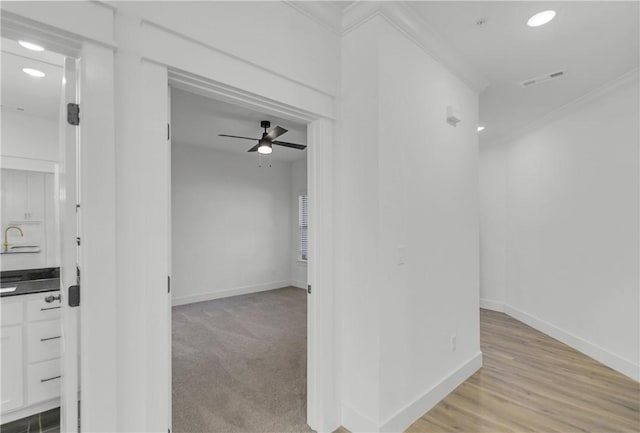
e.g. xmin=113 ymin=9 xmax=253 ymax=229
xmin=338 ymin=310 xmax=640 ymax=433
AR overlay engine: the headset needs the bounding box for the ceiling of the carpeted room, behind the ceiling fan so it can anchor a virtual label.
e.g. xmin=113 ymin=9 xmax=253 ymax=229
xmin=171 ymin=89 xmax=307 ymax=162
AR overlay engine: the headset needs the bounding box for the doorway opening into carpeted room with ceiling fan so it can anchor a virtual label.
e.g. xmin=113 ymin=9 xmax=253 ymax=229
xmin=170 ymin=88 xmax=311 ymax=432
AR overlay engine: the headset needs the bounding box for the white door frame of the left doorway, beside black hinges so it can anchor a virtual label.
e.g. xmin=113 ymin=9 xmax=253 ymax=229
xmin=0 ymin=9 xmax=118 ymax=431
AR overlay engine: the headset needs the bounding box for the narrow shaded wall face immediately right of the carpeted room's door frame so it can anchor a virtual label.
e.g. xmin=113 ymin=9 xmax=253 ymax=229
xmin=335 ymin=20 xmax=380 ymax=432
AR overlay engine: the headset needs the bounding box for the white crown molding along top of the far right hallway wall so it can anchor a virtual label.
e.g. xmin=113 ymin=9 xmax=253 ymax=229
xmin=480 ymin=68 xmax=640 ymax=147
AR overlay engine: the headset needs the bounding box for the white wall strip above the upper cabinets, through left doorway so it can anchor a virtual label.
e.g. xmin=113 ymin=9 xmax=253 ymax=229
xmin=0 ymin=109 xmax=60 ymax=162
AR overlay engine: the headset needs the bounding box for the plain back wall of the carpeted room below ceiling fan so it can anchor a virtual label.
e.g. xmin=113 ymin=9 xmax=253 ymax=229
xmin=171 ymin=144 xmax=297 ymax=305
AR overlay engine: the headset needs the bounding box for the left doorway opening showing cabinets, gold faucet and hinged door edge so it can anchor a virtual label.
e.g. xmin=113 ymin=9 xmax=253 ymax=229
xmin=0 ymin=33 xmax=80 ymax=432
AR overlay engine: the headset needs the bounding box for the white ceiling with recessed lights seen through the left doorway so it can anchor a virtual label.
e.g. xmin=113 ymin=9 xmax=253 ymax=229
xmin=0 ymin=38 xmax=64 ymax=120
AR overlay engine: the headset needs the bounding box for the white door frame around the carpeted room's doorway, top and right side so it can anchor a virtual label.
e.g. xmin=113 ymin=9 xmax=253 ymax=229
xmin=168 ymin=67 xmax=340 ymax=432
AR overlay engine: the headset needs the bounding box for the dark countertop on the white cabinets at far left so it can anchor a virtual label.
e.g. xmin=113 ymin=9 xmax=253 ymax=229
xmin=0 ymin=268 xmax=60 ymax=297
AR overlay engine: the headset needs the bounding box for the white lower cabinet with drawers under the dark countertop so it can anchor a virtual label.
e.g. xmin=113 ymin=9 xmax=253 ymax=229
xmin=0 ymin=291 xmax=62 ymax=423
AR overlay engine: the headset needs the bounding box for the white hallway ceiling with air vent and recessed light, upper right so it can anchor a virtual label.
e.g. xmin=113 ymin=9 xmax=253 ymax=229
xmin=411 ymin=1 xmax=640 ymax=144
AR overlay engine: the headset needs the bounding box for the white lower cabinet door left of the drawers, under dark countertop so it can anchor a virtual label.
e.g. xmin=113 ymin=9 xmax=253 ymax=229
xmin=0 ymin=326 xmax=24 ymax=413
